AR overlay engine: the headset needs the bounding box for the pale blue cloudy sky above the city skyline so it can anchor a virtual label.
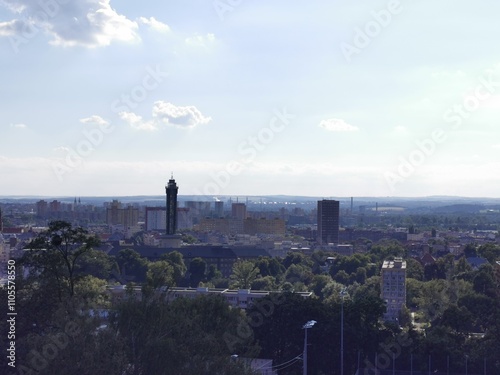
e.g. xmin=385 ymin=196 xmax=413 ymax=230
xmin=0 ymin=0 xmax=500 ymax=199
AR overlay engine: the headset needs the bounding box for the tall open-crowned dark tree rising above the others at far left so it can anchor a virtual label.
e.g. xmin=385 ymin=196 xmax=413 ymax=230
xmin=21 ymin=221 xmax=99 ymax=300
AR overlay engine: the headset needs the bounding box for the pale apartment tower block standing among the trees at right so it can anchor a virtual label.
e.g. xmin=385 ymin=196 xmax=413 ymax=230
xmin=380 ymin=258 xmax=406 ymax=321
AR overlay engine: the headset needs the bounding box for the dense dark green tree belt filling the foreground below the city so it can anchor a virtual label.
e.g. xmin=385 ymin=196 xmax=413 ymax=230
xmin=0 ymin=222 xmax=500 ymax=375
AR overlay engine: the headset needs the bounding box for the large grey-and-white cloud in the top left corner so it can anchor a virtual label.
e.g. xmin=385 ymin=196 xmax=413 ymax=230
xmin=0 ymin=0 xmax=140 ymax=47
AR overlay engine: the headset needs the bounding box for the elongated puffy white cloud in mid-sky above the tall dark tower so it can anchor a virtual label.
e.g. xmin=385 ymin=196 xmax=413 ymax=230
xmin=119 ymin=100 xmax=211 ymax=130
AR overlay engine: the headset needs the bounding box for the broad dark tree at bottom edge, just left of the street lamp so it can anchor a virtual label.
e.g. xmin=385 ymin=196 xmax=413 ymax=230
xmin=111 ymin=295 xmax=254 ymax=375
